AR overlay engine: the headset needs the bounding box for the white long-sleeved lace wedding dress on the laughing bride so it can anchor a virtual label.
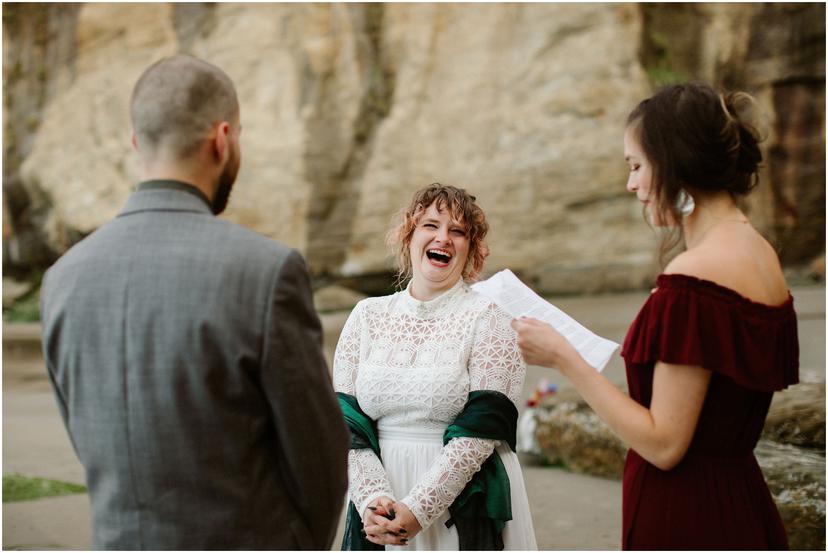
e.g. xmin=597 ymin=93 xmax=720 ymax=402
xmin=334 ymin=280 xmax=537 ymax=551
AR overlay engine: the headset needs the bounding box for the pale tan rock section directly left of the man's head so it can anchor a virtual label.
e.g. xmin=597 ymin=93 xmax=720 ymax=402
xmin=21 ymin=4 xmax=175 ymax=249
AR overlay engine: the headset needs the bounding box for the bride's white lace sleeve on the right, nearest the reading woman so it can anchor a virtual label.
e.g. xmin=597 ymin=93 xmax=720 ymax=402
xmin=402 ymin=305 xmax=526 ymax=529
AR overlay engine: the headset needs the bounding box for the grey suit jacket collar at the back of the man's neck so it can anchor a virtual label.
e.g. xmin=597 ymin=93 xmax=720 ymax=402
xmin=118 ymin=180 xmax=213 ymax=217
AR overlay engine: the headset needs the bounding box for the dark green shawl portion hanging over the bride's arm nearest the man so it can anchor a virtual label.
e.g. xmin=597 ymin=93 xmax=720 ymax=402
xmin=336 ymin=392 xmax=385 ymax=551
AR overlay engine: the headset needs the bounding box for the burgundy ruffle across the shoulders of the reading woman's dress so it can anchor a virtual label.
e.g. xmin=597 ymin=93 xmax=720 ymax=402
xmin=621 ymin=274 xmax=799 ymax=392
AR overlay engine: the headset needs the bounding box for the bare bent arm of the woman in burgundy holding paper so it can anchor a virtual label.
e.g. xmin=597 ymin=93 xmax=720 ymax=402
xmin=512 ymin=318 xmax=711 ymax=470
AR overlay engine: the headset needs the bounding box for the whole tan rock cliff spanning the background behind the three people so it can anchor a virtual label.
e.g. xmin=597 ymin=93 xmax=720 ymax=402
xmin=4 ymin=4 xmax=824 ymax=292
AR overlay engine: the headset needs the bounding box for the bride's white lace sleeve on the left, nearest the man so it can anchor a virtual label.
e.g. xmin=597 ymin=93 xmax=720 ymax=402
xmin=333 ymin=304 xmax=394 ymax=517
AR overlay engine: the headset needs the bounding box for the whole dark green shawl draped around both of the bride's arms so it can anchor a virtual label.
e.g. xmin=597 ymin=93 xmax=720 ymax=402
xmin=337 ymin=390 xmax=518 ymax=551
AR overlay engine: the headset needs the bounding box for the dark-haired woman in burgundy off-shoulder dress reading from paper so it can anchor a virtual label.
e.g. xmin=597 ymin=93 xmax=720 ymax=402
xmin=513 ymin=84 xmax=799 ymax=549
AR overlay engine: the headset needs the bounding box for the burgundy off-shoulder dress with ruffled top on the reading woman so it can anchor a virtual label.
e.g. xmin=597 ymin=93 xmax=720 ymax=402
xmin=621 ymin=274 xmax=799 ymax=549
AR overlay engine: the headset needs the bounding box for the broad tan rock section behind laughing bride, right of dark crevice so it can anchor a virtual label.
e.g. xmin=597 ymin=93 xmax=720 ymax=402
xmin=342 ymin=4 xmax=651 ymax=287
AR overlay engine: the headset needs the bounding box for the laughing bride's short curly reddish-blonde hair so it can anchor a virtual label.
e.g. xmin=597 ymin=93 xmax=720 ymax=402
xmin=386 ymin=182 xmax=489 ymax=287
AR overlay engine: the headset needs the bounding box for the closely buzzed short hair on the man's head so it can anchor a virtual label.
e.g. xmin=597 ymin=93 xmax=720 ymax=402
xmin=130 ymin=55 xmax=239 ymax=159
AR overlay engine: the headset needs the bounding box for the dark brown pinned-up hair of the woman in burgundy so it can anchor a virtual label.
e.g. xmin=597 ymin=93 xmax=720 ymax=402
xmin=627 ymin=83 xmax=762 ymax=263
